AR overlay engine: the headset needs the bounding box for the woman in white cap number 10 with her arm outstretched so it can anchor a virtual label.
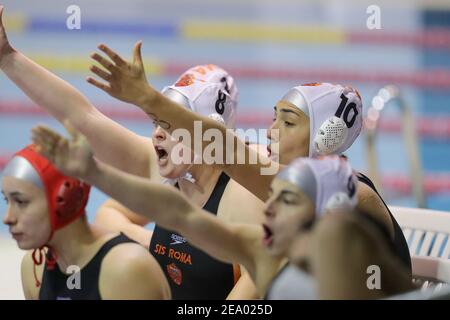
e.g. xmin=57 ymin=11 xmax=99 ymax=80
xmin=83 ymin=38 xmax=411 ymax=270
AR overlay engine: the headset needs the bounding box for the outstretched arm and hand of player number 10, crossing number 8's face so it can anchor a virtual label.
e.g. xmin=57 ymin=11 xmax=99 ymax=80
xmin=88 ymin=42 xmax=278 ymax=200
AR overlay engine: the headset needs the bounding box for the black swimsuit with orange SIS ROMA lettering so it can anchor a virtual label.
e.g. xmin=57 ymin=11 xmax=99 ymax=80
xmin=149 ymin=173 xmax=237 ymax=300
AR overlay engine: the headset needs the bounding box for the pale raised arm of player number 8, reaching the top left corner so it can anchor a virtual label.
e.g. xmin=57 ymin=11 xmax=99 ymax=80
xmin=0 ymin=7 xmax=159 ymax=176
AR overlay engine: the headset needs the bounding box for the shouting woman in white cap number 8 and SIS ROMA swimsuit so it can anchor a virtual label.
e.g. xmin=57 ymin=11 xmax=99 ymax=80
xmin=0 ymin=8 xmax=263 ymax=299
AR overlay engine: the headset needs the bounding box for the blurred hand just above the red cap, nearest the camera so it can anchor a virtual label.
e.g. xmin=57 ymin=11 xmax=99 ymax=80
xmin=32 ymin=122 xmax=97 ymax=181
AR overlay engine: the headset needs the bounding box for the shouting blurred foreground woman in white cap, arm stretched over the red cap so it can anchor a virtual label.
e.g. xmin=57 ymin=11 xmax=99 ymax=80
xmin=33 ymin=127 xmax=414 ymax=296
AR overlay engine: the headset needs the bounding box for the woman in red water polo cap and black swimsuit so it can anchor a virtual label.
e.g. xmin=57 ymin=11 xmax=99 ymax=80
xmin=2 ymin=145 xmax=170 ymax=300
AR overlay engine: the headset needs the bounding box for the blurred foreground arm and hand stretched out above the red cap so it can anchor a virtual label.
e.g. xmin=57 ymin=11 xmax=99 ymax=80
xmin=33 ymin=127 xmax=262 ymax=274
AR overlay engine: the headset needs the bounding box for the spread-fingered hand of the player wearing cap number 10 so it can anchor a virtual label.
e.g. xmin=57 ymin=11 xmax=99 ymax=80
xmin=87 ymin=41 xmax=156 ymax=106
